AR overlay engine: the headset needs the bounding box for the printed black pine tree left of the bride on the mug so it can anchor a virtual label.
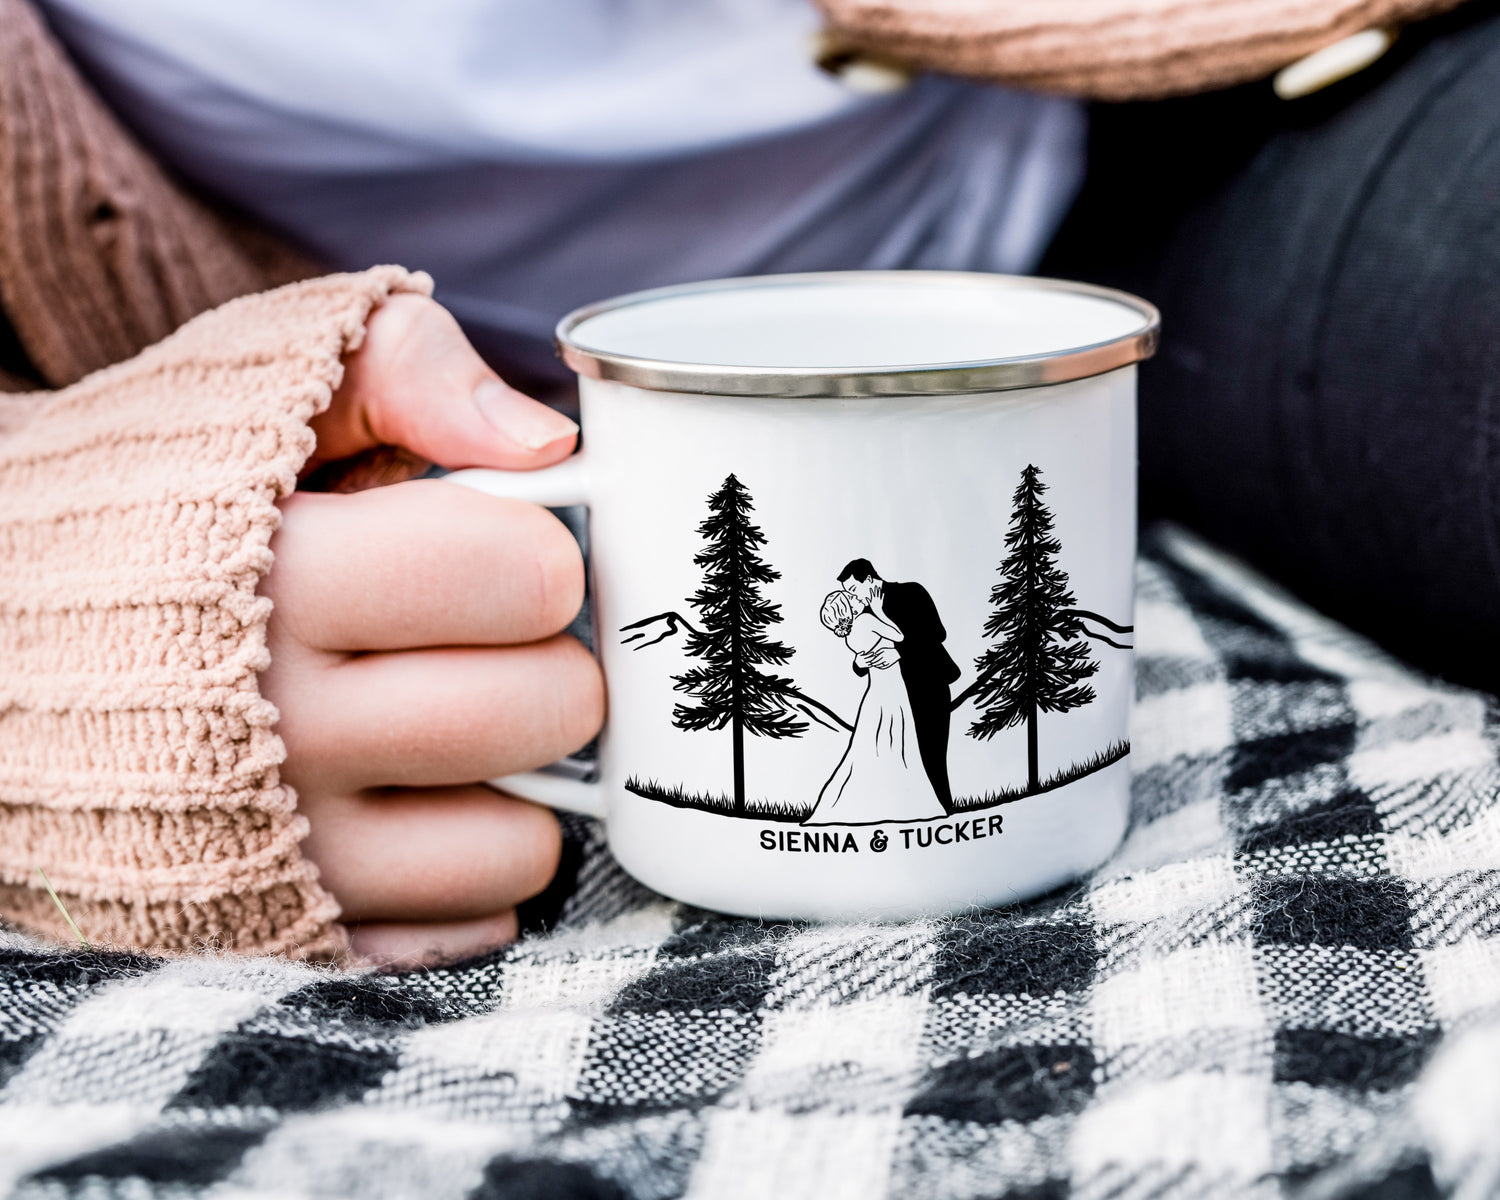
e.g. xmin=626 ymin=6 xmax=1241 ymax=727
xmin=672 ymin=476 xmax=807 ymax=816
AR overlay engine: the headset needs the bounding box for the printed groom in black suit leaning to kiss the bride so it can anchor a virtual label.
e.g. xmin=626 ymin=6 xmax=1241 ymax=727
xmin=839 ymin=558 xmax=960 ymax=812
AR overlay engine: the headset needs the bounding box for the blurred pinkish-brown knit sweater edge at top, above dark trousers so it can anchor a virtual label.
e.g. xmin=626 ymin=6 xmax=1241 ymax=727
xmin=818 ymin=0 xmax=1461 ymax=101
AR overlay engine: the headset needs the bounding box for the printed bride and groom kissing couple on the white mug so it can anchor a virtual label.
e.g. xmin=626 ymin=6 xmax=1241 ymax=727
xmin=806 ymin=558 xmax=960 ymax=825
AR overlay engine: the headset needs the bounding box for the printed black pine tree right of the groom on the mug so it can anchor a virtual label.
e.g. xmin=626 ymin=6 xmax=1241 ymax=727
xmin=969 ymin=467 xmax=1100 ymax=792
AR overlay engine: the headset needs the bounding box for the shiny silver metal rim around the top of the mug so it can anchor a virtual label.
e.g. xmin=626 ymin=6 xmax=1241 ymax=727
xmin=557 ymin=272 xmax=1161 ymax=399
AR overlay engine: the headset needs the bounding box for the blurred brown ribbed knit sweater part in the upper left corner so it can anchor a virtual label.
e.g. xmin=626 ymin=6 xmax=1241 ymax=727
xmin=0 ymin=0 xmax=318 ymax=390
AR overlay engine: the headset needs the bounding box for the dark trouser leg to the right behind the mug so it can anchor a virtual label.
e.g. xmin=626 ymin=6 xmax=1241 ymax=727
xmin=1044 ymin=0 xmax=1500 ymax=690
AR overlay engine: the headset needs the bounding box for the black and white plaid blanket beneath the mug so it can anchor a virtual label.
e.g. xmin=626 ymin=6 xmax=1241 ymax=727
xmin=0 ymin=530 xmax=1500 ymax=1200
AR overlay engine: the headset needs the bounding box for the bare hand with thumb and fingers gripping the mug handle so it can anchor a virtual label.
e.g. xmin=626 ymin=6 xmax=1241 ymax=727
xmin=261 ymin=296 xmax=605 ymax=965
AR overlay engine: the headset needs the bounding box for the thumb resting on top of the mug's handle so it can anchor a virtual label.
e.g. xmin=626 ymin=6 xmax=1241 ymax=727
xmin=311 ymin=296 xmax=578 ymax=471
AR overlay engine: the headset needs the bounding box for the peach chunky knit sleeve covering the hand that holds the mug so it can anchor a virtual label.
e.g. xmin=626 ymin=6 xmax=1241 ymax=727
xmin=0 ymin=267 xmax=431 ymax=957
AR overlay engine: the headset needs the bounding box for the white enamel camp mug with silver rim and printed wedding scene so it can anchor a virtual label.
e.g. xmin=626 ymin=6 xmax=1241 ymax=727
xmin=449 ymin=272 xmax=1158 ymax=920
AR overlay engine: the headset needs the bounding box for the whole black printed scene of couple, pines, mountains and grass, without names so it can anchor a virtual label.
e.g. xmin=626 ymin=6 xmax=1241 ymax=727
xmin=621 ymin=465 xmax=1134 ymax=825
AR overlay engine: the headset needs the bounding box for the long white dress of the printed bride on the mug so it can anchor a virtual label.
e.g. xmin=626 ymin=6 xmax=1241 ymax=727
xmin=803 ymin=614 xmax=945 ymax=825
